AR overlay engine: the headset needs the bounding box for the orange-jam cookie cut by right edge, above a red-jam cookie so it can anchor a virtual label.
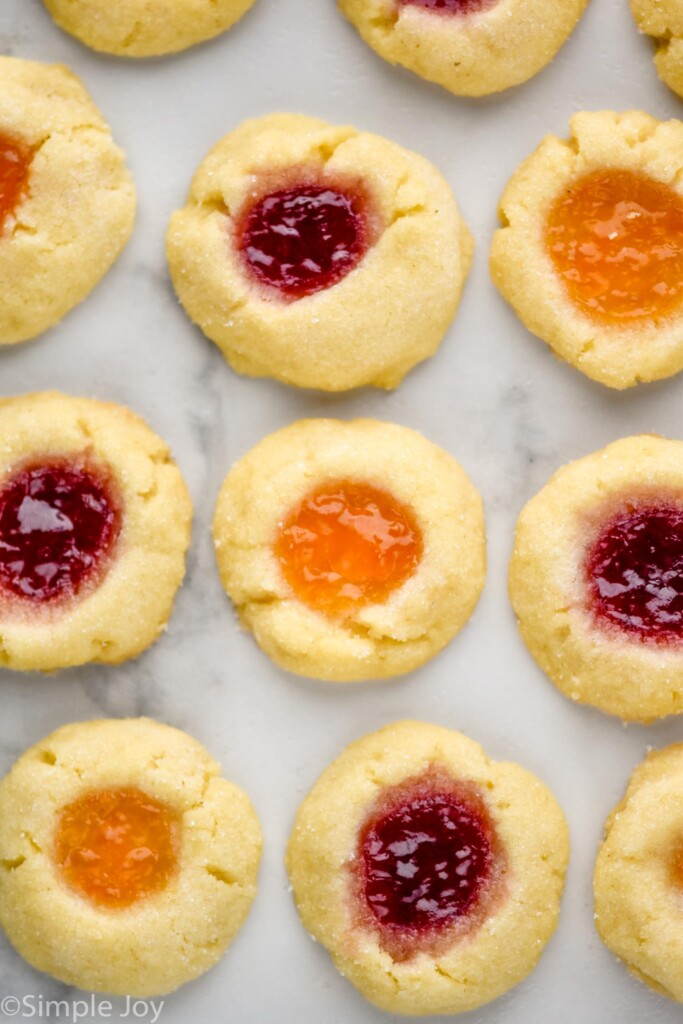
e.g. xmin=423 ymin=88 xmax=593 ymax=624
xmin=490 ymin=112 xmax=683 ymax=388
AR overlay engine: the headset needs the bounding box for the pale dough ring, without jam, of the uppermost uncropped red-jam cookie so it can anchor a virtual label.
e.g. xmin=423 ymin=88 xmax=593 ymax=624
xmin=167 ymin=114 xmax=473 ymax=391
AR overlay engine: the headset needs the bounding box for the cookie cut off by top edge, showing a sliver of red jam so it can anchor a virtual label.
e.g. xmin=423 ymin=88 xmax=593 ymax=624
xmin=339 ymin=0 xmax=588 ymax=96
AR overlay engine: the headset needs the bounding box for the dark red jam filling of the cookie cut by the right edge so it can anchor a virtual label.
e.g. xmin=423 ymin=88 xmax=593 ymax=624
xmin=586 ymin=501 xmax=683 ymax=643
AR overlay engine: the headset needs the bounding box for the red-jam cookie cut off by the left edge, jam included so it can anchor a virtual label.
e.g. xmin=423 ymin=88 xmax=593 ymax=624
xmin=0 ymin=392 xmax=191 ymax=671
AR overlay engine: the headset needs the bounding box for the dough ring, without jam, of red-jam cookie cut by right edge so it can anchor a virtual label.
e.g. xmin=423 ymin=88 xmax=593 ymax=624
xmin=510 ymin=435 xmax=683 ymax=722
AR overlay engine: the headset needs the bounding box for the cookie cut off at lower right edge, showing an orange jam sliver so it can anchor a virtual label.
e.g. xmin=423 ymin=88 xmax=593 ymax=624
xmin=594 ymin=743 xmax=683 ymax=1002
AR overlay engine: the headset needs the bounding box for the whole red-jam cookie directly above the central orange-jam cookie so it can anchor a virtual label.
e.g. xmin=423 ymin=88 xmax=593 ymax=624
xmin=167 ymin=114 xmax=473 ymax=391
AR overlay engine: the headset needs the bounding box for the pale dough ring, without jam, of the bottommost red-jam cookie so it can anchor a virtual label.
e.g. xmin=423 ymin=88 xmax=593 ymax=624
xmin=287 ymin=722 xmax=569 ymax=1016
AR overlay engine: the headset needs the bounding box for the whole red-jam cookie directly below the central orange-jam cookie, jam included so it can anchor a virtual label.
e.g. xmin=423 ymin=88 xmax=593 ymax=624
xmin=287 ymin=722 xmax=568 ymax=1015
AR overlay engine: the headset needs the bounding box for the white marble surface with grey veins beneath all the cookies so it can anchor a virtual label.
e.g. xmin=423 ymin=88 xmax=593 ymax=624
xmin=0 ymin=0 xmax=683 ymax=1024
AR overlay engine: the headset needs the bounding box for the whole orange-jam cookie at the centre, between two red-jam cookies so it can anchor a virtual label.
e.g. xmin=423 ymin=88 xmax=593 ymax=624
xmin=214 ymin=420 xmax=485 ymax=682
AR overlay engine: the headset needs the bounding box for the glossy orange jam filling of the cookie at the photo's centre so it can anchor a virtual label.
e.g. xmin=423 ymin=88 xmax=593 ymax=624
xmin=275 ymin=480 xmax=423 ymax=617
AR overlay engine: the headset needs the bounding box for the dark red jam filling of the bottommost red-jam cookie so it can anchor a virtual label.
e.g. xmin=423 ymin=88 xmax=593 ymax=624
xmin=356 ymin=768 xmax=502 ymax=959
